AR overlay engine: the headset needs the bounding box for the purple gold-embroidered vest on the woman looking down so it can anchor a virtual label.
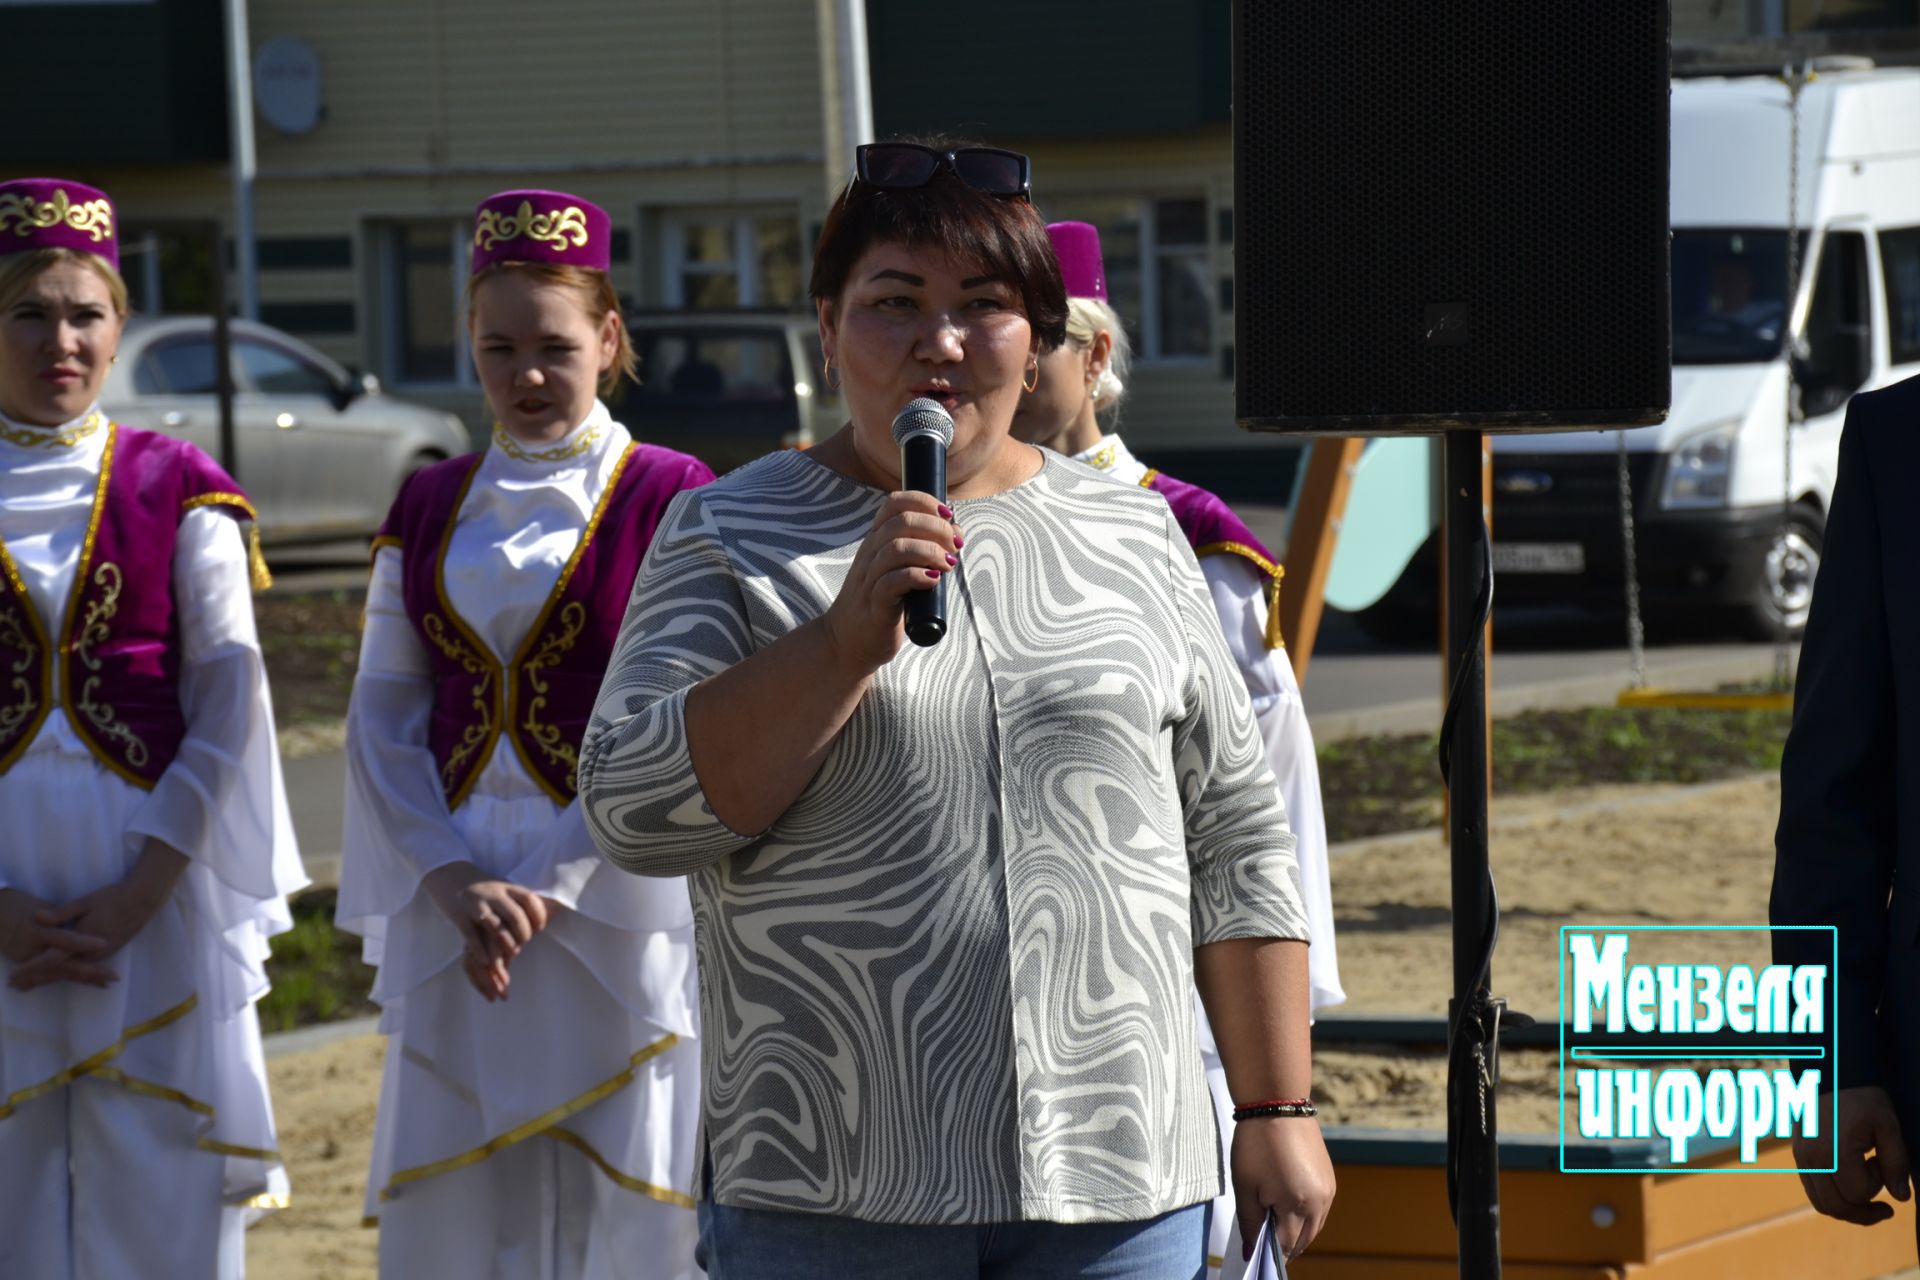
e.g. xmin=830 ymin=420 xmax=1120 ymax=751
xmin=374 ymin=445 xmax=714 ymax=810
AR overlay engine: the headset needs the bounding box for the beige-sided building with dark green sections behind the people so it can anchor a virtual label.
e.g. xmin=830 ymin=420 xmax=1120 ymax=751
xmin=15 ymin=0 xmax=1914 ymax=470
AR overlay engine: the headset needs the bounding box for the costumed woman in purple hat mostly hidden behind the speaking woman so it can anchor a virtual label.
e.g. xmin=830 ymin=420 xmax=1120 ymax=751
xmin=1014 ymin=223 xmax=1346 ymax=1276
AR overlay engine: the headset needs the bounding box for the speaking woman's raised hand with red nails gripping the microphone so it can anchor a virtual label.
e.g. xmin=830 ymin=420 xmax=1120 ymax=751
xmin=826 ymin=493 xmax=964 ymax=677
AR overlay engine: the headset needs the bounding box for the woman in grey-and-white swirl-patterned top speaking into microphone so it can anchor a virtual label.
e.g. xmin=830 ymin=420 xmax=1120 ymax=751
xmin=580 ymin=144 xmax=1332 ymax=1280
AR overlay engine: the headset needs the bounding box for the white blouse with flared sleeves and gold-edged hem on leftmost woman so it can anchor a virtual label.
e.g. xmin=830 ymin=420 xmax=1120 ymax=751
xmin=0 ymin=411 xmax=307 ymax=1205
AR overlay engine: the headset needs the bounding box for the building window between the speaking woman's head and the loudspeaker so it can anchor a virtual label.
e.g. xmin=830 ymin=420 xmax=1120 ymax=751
xmin=1046 ymin=196 xmax=1215 ymax=361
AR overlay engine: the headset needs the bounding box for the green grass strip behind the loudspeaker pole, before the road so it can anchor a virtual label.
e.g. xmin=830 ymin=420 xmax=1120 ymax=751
xmin=1319 ymin=694 xmax=1791 ymax=841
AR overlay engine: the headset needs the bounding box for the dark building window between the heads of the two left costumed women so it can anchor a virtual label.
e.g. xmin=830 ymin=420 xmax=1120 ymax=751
xmin=376 ymin=219 xmax=476 ymax=386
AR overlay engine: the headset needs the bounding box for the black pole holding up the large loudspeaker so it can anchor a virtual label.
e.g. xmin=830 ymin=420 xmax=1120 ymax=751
xmin=1440 ymin=432 xmax=1500 ymax=1280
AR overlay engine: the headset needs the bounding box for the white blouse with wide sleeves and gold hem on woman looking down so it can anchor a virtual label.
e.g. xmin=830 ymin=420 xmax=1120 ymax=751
xmin=338 ymin=405 xmax=699 ymax=1274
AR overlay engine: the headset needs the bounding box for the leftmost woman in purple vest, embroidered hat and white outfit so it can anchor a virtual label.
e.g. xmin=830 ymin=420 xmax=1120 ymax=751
xmin=0 ymin=178 xmax=305 ymax=1280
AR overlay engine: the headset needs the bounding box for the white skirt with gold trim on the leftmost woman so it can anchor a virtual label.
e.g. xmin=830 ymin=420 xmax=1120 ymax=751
xmin=0 ymin=750 xmax=288 ymax=1276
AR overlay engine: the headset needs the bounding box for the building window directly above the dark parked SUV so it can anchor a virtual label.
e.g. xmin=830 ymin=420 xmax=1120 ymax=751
xmin=662 ymin=211 xmax=806 ymax=311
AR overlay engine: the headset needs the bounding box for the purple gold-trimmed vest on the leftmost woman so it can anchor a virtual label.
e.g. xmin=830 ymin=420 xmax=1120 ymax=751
xmin=0 ymin=426 xmax=253 ymax=789
